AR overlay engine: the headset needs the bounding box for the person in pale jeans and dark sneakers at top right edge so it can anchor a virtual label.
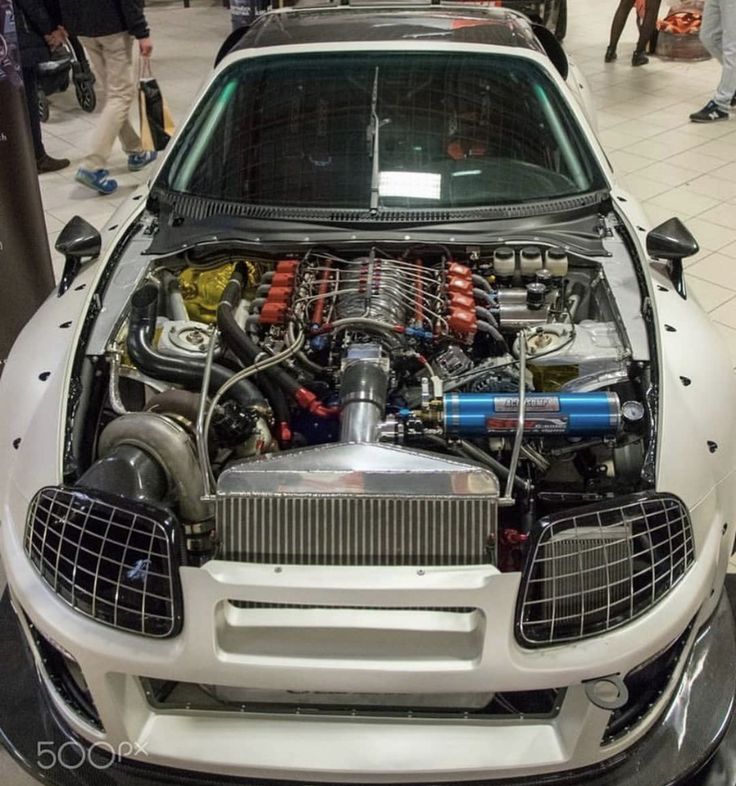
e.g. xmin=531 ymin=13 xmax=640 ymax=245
xmin=690 ymin=0 xmax=736 ymax=123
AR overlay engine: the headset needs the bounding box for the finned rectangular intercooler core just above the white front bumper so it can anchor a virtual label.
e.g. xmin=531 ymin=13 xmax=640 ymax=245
xmin=216 ymin=495 xmax=496 ymax=565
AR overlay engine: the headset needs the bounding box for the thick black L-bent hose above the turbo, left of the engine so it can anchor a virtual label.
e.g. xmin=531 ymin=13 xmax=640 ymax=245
xmin=128 ymin=284 xmax=264 ymax=407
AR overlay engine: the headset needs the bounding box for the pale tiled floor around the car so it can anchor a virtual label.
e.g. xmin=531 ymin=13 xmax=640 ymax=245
xmin=0 ymin=0 xmax=736 ymax=786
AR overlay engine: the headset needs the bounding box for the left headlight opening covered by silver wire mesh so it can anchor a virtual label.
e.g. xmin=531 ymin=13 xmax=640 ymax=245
xmin=24 ymin=486 xmax=182 ymax=637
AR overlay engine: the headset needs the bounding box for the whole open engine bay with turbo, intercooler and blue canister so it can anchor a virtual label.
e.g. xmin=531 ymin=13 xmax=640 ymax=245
xmin=75 ymin=244 xmax=651 ymax=569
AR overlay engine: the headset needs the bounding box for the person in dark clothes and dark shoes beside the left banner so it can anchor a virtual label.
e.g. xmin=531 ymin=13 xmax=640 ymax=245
xmin=13 ymin=0 xmax=69 ymax=175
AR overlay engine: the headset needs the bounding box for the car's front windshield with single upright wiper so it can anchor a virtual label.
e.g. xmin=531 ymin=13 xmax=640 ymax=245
xmin=164 ymin=52 xmax=605 ymax=209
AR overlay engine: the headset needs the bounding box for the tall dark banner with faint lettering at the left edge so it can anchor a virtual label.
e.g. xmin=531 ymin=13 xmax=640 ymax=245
xmin=0 ymin=0 xmax=54 ymax=371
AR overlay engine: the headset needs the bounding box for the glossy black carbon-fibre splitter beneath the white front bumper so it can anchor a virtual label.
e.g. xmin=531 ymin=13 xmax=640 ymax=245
xmin=0 ymin=592 xmax=736 ymax=786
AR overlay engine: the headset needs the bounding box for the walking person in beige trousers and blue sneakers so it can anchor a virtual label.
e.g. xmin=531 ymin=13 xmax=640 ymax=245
xmin=59 ymin=0 xmax=156 ymax=194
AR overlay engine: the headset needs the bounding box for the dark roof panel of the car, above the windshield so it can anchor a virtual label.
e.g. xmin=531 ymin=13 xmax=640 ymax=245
xmin=230 ymin=0 xmax=544 ymax=52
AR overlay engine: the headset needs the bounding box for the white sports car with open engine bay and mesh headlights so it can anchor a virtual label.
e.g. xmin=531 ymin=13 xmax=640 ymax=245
xmin=0 ymin=3 xmax=736 ymax=786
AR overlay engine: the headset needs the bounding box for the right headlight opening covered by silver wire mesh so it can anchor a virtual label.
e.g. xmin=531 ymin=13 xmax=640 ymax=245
xmin=517 ymin=493 xmax=695 ymax=646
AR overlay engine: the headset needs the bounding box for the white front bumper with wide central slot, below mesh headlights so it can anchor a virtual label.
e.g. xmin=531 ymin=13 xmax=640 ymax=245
xmin=0 ymin=480 xmax=722 ymax=784
